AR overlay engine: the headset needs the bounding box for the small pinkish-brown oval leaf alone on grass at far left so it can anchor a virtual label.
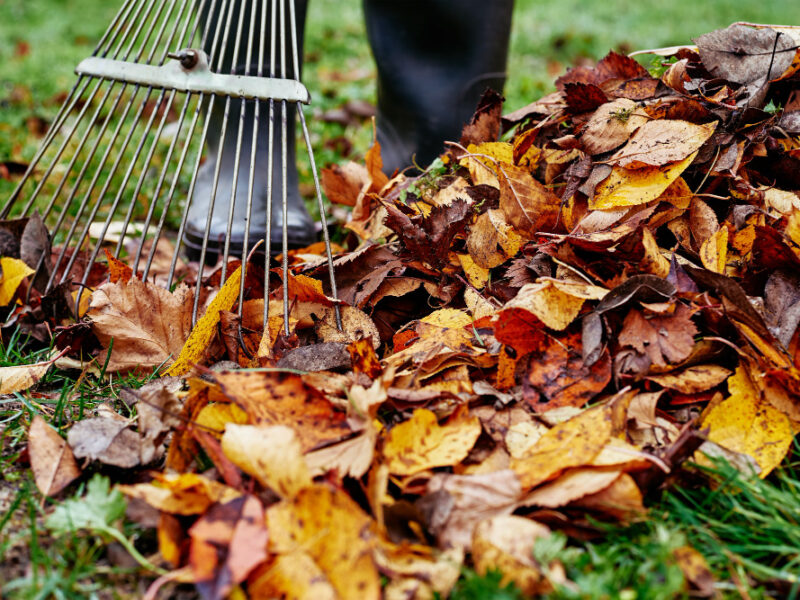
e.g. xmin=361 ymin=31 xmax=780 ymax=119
xmin=28 ymin=415 xmax=81 ymax=496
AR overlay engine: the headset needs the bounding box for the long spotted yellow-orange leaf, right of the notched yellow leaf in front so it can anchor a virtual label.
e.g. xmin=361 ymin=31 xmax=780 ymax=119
xmin=510 ymin=405 xmax=613 ymax=490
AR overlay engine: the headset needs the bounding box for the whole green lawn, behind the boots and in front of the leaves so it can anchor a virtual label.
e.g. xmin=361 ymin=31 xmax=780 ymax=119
xmin=0 ymin=0 xmax=800 ymax=600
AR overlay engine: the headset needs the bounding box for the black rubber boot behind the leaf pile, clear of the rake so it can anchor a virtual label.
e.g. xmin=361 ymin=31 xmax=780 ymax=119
xmin=364 ymin=0 xmax=514 ymax=174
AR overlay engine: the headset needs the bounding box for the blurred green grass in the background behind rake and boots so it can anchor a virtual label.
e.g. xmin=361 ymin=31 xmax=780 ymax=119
xmin=0 ymin=0 xmax=800 ymax=203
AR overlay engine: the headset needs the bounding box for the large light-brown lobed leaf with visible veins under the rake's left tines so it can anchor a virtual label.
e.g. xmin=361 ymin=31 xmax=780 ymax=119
xmin=87 ymin=279 xmax=192 ymax=372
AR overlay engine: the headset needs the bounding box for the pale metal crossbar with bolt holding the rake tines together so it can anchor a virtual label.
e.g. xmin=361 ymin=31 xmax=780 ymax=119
xmin=75 ymin=48 xmax=311 ymax=104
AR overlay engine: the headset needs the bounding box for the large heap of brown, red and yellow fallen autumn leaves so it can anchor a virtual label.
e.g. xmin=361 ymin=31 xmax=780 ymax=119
xmin=0 ymin=25 xmax=800 ymax=598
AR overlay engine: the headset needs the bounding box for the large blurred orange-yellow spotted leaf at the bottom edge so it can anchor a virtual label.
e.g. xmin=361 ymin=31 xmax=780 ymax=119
xmin=262 ymin=485 xmax=380 ymax=600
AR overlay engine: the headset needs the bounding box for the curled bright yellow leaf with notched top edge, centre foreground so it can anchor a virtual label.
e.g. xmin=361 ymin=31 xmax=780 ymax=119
xmin=383 ymin=408 xmax=481 ymax=475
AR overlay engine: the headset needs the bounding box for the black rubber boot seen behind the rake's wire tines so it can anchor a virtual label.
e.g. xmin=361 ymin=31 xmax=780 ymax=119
xmin=184 ymin=0 xmax=316 ymax=263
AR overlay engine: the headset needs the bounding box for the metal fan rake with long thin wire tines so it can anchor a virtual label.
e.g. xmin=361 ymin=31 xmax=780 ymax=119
xmin=0 ymin=0 xmax=341 ymax=340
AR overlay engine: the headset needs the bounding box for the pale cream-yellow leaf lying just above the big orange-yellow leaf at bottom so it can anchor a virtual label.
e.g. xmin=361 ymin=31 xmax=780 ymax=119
xmin=222 ymin=423 xmax=311 ymax=498
